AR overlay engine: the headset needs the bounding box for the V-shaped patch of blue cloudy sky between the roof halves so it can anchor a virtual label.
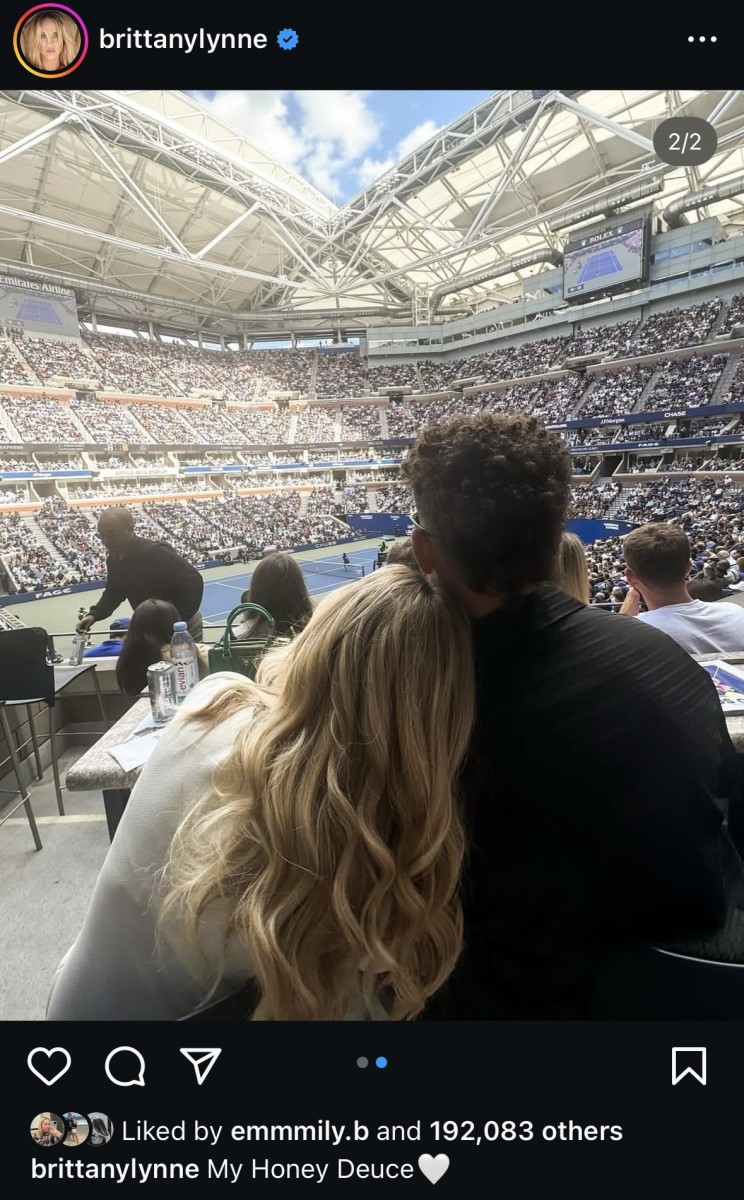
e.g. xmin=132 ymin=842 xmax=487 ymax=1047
xmin=188 ymin=90 xmax=491 ymax=204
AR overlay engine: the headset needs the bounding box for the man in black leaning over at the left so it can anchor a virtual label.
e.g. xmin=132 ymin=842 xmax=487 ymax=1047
xmin=77 ymin=509 xmax=204 ymax=642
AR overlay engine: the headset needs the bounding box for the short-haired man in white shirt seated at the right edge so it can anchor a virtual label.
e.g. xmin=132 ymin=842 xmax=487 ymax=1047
xmin=620 ymin=522 xmax=744 ymax=654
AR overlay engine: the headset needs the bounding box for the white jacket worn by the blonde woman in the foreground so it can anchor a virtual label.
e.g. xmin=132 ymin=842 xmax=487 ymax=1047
xmin=47 ymin=672 xmax=252 ymax=1021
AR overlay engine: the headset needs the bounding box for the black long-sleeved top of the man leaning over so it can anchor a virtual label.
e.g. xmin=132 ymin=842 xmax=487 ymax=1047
xmin=89 ymin=538 xmax=204 ymax=620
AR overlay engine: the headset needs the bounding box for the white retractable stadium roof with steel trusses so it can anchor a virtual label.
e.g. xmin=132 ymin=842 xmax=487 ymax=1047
xmin=0 ymin=90 xmax=744 ymax=337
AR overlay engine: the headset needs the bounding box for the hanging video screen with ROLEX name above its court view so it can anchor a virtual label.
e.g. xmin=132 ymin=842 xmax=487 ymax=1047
xmin=563 ymin=217 xmax=649 ymax=300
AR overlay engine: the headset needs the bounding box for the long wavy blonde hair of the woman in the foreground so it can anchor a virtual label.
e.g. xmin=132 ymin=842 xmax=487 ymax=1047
xmin=160 ymin=566 xmax=474 ymax=1020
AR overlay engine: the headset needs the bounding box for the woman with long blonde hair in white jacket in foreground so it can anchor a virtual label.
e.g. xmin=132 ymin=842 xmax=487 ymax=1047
xmin=48 ymin=566 xmax=474 ymax=1020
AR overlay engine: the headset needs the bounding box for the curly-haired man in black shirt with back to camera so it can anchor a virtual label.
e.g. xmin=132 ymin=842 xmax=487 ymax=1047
xmin=403 ymin=414 xmax=742 ymax=1019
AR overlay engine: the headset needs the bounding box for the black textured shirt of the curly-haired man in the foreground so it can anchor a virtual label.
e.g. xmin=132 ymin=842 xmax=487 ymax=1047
xmin=425 ymin=587 xmax=742 ymax=1019
